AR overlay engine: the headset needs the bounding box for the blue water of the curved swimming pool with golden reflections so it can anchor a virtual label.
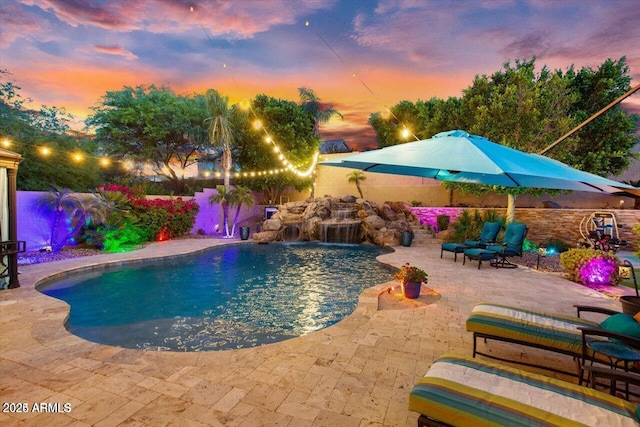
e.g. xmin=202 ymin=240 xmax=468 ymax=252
xmin=39 ymin=243 xmax=393 ymax=351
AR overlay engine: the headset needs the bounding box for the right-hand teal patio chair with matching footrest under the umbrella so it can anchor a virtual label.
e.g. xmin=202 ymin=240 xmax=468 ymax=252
xmin=462 ymin=222 xmax=529 ymax=269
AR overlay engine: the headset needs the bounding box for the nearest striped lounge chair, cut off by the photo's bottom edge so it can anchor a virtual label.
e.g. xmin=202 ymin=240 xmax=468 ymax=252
xmin=409 ymin=354 xmax=640 ymax=427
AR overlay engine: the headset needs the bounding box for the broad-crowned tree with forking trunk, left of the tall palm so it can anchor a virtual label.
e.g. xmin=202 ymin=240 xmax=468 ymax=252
xmin=86 ymin=85 xmax=208 ymax=194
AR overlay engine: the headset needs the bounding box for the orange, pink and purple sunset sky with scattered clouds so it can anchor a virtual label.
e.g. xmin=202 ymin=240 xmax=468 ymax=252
xmin=0 ymin=0 xmax=640 ymax=147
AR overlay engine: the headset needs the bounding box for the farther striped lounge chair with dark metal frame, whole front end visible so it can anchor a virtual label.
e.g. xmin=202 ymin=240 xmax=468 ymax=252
xmin=466 ymin=303 xmax=640 ymax=377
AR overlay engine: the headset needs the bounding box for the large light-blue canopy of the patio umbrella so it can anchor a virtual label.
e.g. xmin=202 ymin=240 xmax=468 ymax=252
xmin=320 ymin=130 xmax=640 ymax=196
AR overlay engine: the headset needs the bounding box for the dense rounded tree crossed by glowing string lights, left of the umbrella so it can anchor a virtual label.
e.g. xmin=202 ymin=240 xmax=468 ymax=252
xmin=234 ymin=95 xmax=320 ymax=204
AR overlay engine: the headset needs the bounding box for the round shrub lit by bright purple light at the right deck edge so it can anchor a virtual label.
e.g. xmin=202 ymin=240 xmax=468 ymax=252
xmin=560 ymin=249 xmax=620 ymax=286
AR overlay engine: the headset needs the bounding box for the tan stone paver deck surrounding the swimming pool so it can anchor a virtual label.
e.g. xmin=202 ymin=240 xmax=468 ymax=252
xmin=0 ymin=239 xmax=632 ymax=426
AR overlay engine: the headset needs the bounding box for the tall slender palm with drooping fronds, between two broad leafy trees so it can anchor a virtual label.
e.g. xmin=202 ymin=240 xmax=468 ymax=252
xmin=206 ymin=89 xmax=235 ymax=188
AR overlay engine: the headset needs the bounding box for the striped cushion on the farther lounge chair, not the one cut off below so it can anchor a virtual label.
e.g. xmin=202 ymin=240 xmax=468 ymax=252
xmin=467 ymin=303 xmax=598 ymax=355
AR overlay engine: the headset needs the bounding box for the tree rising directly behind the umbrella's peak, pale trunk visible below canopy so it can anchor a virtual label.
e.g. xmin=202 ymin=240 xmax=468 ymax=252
xmin=456 ymin=58 xmax=575 ymax=222
